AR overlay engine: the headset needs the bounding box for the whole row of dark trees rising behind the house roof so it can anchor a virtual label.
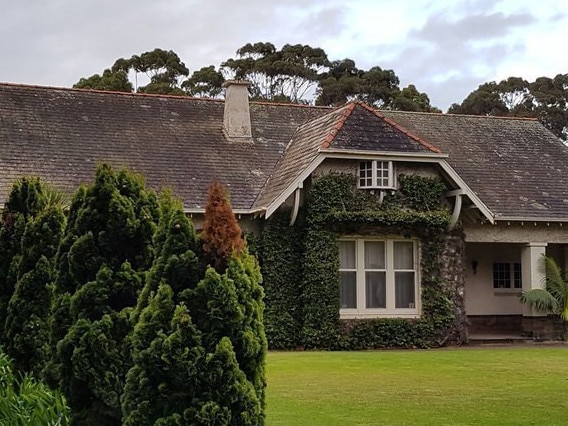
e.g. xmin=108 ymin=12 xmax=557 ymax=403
xmin=74 ymin=42 xmax=568 ymax=141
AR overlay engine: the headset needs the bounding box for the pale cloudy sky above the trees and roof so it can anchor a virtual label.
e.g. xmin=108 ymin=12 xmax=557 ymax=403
xmin=0 ymin=0 xmax=568 ymax=111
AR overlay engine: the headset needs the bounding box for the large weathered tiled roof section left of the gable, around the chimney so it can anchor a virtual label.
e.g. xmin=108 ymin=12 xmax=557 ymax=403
xmin=0 ymin=84 xmax=328 ymax=210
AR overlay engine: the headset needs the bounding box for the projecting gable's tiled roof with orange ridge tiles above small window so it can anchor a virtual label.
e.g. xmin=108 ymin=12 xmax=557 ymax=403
xmin=255 ymin=102 xmax=440 ymax=215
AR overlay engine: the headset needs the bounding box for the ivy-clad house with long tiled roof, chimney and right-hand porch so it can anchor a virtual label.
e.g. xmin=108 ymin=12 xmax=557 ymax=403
xmin=0 ymin=81 xmax=568 ymax=348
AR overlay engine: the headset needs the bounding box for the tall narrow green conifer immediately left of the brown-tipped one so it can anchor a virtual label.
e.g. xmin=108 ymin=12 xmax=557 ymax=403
xmin=122 ymin=193 xmax=203 ymax=425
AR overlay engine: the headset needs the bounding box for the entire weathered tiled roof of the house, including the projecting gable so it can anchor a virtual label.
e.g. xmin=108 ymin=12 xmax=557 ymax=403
xmin=0 ymin=84 xmax=568 ymax=220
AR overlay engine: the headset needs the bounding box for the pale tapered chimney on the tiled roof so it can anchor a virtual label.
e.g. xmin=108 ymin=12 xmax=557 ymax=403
xmin=223 ymin=80 xmax=252 ymax=139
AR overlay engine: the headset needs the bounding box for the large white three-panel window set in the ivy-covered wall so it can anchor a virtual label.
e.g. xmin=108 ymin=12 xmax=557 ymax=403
xmin=339 ymin=239 xmax=418 ymax=318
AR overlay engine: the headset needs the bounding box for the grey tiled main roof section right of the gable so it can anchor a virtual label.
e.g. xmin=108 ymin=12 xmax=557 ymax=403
xmin=383 ymin=111 xmax=568 ymax=220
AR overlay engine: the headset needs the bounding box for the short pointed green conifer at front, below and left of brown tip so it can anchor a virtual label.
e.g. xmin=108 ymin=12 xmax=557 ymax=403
xmin=122 ymin=282 xmax=206 ymax=426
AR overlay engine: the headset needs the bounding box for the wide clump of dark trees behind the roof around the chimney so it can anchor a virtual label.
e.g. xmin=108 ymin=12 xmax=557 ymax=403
xmin=74 ymin=42 xmax=439 ymax=112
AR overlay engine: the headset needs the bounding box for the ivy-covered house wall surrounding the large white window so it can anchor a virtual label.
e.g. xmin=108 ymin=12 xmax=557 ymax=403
xmin=259 ymin=173 xmax=466 ymax=349
